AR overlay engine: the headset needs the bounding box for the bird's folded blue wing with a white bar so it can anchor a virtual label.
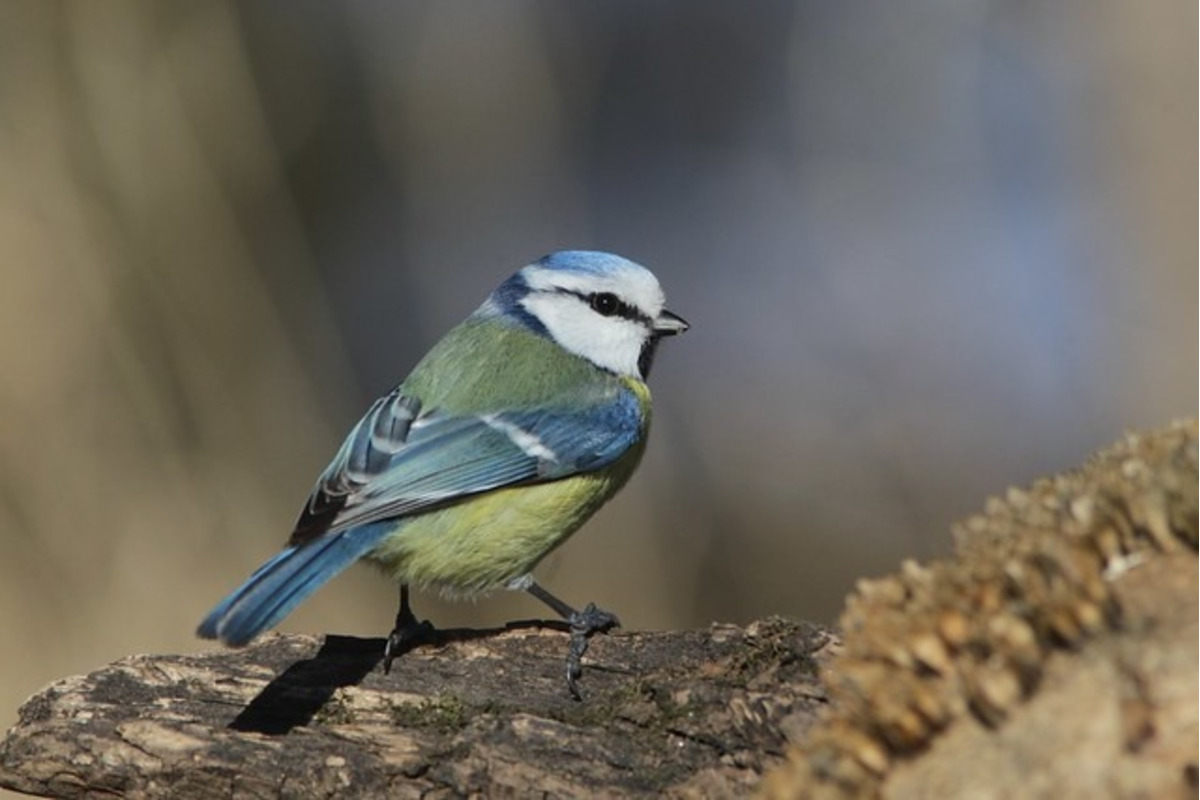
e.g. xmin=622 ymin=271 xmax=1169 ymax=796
xmin=290 ymin=387 xmax=642 ymax=545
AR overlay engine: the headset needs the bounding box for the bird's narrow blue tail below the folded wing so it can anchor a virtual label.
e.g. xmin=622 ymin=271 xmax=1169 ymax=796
xmin=196 ymin=523 xmax=390 ymax=646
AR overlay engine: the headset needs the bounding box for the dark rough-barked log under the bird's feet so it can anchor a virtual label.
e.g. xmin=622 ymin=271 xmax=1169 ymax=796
xmin=0 ymin=619 xmax=836 ymax=798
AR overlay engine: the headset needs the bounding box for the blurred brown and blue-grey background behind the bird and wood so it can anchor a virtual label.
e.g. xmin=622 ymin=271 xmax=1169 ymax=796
xmin=0 ymin=0 xmax=1198 ymax=726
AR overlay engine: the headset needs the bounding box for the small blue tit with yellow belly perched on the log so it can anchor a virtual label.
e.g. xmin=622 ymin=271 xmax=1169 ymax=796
xmin=197 ymin=251 xmax=689 ymax=699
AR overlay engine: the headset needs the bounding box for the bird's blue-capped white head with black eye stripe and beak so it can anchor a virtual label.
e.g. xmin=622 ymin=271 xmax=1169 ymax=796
xmin=480 ymin=251 xmax=688 ymax=380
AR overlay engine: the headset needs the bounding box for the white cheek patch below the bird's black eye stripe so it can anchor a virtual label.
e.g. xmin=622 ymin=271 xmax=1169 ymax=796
xmin=521 ymin=293 xmax=649 ymax=378
